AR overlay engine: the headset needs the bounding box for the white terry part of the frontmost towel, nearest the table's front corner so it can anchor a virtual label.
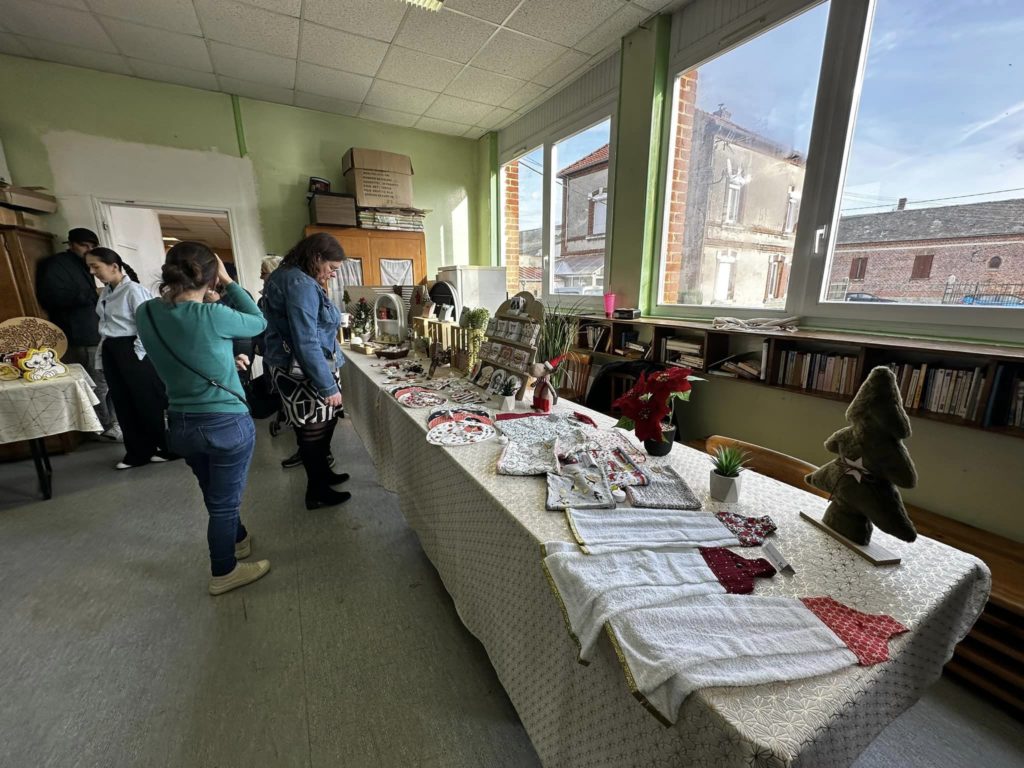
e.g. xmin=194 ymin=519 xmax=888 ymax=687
xmin=608 ymin=595 xmax=857 ymax=723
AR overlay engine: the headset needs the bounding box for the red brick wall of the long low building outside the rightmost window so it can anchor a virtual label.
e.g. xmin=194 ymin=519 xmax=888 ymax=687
xmin=829 ymin=236 xmax=1024 ymax=303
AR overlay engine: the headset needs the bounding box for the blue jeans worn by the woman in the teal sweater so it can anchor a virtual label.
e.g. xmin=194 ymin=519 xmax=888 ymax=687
xmin=167 ymin=411 xmax=256 ymax=577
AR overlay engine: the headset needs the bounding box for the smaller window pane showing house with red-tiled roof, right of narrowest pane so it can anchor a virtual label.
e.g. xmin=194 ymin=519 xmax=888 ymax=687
xmin=550 ymin=120 xmax=611 ymax=296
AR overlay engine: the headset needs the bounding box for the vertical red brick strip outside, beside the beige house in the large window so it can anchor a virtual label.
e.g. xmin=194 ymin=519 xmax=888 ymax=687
xmin=662 ymin=71 xmax=697 ymax=303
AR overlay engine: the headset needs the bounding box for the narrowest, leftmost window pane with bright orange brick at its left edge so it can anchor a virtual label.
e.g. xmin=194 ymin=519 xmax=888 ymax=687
xmin=502 ymin=146 xmax=544 ymax=296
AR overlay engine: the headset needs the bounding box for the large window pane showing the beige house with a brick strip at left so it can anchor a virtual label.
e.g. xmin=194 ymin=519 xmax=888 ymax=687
xmin=659 ymin=3 xmax=828 ymax=307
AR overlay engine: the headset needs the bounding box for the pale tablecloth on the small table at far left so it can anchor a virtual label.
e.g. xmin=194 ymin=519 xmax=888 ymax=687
xmin=0 ymin=366 xmax=103 ymax=442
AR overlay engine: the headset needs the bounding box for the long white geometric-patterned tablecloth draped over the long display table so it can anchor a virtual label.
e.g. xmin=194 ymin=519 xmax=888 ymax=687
xmin=341 ymin=353 xmax=990 ymax=768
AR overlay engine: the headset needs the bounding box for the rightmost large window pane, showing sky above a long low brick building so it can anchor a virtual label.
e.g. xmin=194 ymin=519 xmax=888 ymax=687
xmin=822 ymin=0 xmax=1024 ymax=307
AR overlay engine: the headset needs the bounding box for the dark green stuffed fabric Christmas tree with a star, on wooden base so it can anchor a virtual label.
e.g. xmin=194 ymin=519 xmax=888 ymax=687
xmin=806 ymin=366 xmax=918 ymax=544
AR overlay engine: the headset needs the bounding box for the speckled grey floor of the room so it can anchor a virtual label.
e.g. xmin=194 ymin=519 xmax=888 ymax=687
xmin=0 ymin=422 xmax=1024 ymax=768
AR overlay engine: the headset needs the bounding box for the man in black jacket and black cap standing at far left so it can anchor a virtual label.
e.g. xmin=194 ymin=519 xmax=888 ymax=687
xmin=36 ymin=227 xmax=121 ymax=439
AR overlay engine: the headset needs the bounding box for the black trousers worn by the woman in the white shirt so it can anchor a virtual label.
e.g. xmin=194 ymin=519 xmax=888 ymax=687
xmin=102 ymin=336 xmax=167 ymax=464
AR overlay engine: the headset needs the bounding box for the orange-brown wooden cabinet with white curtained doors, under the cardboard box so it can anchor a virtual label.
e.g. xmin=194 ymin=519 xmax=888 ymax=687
xmin=305 ymin=226 xmax=427 ymax=286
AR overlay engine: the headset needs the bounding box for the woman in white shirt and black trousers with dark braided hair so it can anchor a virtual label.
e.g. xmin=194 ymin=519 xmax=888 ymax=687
xmin=85 ymin=248 xmax=175 ymax=469
